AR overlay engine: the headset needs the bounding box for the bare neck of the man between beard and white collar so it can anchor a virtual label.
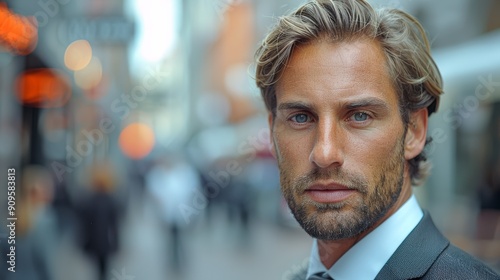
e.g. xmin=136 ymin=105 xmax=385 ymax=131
xmin=318 ymin=180 xmax=412 ymax=269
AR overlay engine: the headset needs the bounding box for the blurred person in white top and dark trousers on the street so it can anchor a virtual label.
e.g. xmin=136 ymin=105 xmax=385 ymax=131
xmin=146 ymin=153 xmax=202 ymax=272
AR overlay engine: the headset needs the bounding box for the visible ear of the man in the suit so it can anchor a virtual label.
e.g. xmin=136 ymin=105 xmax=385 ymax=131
xmin=405 ymin=108 xmax=428 ymax=160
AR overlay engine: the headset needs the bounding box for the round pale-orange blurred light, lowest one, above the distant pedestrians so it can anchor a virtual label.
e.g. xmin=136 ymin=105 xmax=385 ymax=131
xmin=119 ymin=123 xmax=155 ymax=159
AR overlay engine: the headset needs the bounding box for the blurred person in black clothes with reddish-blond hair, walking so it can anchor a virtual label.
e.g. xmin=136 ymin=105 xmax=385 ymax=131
xmin=80 ymin=163 xmax=120 ymax=280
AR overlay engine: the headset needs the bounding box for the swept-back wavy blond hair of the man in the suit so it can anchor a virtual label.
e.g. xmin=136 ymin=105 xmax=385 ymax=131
xmin=255 ymin=0 xmax=443 ymax=185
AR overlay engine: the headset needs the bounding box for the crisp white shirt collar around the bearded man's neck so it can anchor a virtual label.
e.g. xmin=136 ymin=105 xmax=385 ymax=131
xmin=307 ymin=195 xmax=423 ymax=280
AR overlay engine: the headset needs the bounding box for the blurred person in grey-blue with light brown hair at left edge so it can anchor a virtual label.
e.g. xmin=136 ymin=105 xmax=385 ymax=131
xmin=0 ymin=165 xmax=58 ymax=280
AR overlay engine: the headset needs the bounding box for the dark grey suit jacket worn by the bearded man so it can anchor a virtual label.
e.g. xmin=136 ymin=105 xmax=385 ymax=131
xmin=287 ymin=213 xmax=500 ymax=280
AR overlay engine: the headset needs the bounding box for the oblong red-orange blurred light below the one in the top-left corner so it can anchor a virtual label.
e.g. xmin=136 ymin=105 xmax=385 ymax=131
xmin=16 ymin=68 xmax=71 ymax=108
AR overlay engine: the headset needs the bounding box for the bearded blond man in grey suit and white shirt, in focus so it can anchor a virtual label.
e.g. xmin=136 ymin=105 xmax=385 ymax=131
xmin=256 ymin=0 xmax=500 ymax=280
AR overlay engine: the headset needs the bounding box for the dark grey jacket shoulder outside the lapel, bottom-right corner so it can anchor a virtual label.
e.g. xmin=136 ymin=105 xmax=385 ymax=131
xmin=423 ymin=244 xmax=500 ymax=280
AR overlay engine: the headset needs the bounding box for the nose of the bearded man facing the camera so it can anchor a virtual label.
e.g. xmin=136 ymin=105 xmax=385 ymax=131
xmin=309 ymin=120 xmax=344 ymax=168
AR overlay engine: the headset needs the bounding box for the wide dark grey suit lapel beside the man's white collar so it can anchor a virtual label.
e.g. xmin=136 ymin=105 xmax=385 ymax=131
xmin=375 ymin=212 xmax=450 ymax=280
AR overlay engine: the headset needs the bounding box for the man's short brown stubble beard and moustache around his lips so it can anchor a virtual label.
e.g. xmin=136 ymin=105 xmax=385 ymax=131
xmin=278 ymin=138 xmax=405 ymax=240
